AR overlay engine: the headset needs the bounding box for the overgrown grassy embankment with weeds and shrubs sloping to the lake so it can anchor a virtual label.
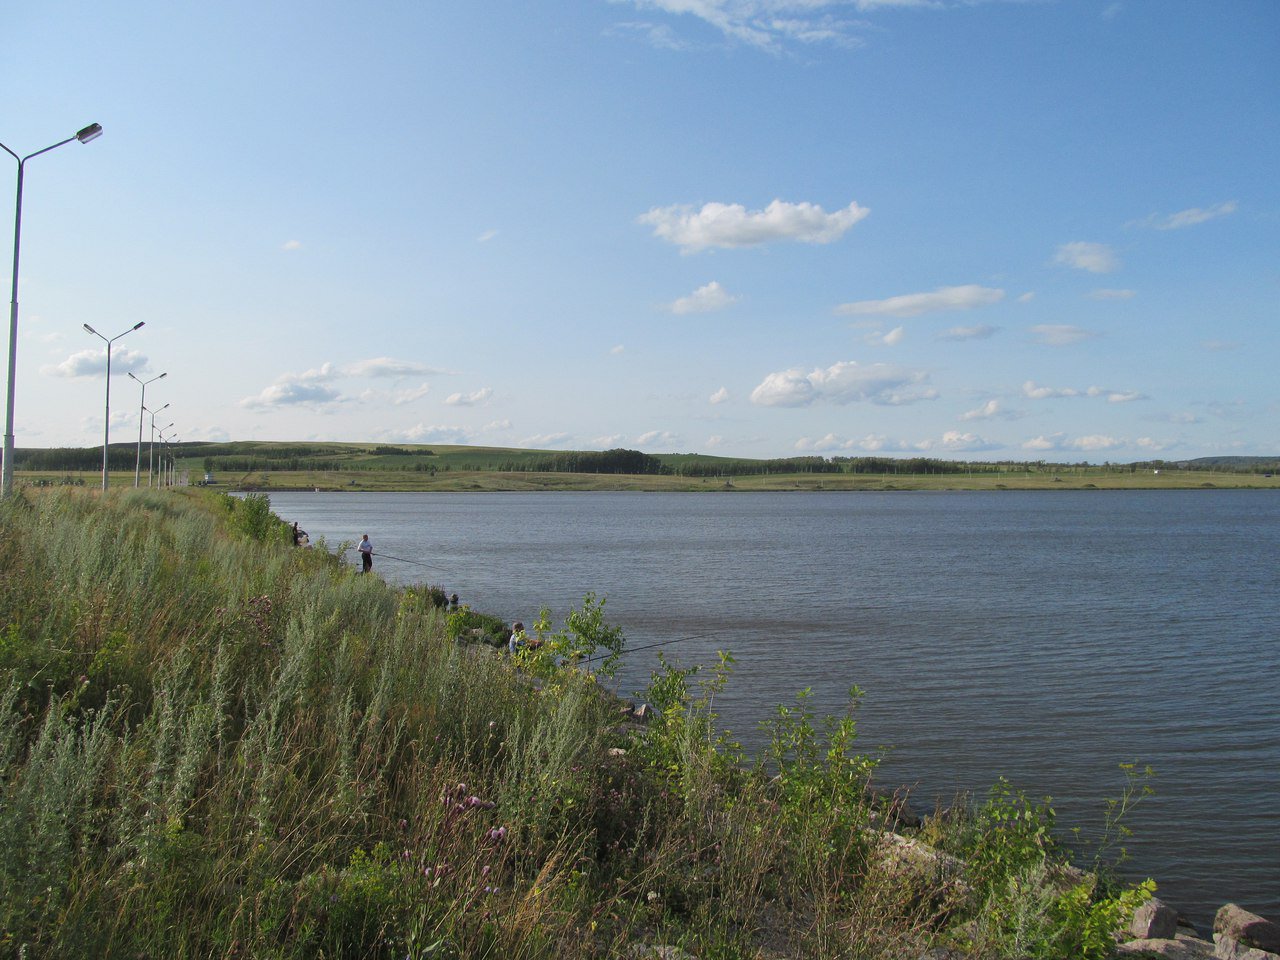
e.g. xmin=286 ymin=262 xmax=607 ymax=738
xmin=0 ymin=489 xmax=1162 ymax=960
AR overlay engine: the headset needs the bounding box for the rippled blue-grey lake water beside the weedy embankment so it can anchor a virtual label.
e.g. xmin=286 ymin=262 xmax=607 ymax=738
xmin=264 ymin=490 xmax=1280 ymax=933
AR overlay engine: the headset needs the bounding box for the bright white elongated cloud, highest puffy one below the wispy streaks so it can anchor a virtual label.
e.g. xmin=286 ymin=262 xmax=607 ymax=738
xmin=636 ymin=200 xmax=870 ymax=253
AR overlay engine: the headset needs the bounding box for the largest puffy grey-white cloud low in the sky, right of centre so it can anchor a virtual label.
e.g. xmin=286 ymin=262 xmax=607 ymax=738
xmin=751 ymin=360 xmax=937 ymax=407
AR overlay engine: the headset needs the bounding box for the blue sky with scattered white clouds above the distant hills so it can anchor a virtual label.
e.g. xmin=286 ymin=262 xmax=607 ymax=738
xmin=0 ymin=0 xmax=1280 ymax=462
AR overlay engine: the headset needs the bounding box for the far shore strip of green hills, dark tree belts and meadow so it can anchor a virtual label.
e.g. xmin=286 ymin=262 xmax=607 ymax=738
xmin=14 ymin=442 xmax=1280 ymax=493
